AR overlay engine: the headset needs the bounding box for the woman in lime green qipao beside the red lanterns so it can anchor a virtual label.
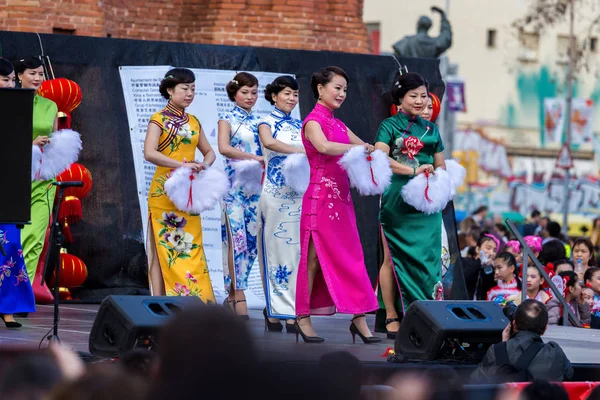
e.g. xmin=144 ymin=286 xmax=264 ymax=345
xmin=15 ymin=57 xmax=58 ymax=285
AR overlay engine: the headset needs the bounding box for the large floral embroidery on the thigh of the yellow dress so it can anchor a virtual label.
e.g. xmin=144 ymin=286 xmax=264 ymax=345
xmin=158 ymin=212 xmax=200 ymax=268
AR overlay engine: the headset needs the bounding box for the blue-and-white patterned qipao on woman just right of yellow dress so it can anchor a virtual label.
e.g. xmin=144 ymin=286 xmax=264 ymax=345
xmin=219 ymin=105 xmax=262 ymax=291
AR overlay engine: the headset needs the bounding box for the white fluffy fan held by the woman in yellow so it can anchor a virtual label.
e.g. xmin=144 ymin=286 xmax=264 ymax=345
xmin=165 ymin=166 xmax=229 ymax=214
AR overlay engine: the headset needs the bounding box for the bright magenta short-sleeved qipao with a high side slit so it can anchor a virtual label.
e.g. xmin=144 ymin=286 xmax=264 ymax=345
xmin=296 ymin=104 xmax=378 ymax=315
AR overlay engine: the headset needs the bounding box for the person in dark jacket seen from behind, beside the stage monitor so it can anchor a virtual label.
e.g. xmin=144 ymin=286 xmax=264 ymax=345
xmin=472 ymin=299 xmax=573 ymax=382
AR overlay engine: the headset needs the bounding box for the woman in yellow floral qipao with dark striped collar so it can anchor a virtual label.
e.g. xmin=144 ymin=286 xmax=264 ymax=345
xmin=144 ymin=68 xmax=215 ymax=303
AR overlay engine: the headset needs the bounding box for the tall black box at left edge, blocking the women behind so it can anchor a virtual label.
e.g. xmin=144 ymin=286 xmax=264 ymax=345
xmin=0 ymin=88 xmax=35 ymax=225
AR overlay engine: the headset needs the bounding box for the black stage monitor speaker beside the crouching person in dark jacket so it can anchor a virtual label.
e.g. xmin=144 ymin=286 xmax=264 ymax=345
xmin=394 ymin=301 xmax=509 ymax=363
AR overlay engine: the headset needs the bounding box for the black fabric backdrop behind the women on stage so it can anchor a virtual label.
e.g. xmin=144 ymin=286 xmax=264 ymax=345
xmin=0 ymin=32 xmax=443 ymax=300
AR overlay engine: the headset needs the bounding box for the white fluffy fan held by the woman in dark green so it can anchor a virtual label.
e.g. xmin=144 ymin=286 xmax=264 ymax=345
xmin=402 ymin=168 xmax=451 ymax=214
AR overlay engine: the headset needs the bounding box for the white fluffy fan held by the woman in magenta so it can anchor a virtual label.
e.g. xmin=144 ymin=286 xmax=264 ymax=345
xmin=338 ymin=146 xmax=392 ymax=196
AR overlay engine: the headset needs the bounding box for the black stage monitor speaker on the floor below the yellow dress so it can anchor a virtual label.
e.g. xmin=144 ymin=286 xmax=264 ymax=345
xmin=89 ymin=296 xmax=204 ymax=357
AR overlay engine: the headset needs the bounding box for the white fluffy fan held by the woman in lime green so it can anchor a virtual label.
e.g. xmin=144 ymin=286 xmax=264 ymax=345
xmin=39 ymin=129 xmax=81 ymax=180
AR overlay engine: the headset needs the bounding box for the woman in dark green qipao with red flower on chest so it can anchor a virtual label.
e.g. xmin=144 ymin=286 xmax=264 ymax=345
xmin=375 ymin=73 xmax=446 ymax=337
